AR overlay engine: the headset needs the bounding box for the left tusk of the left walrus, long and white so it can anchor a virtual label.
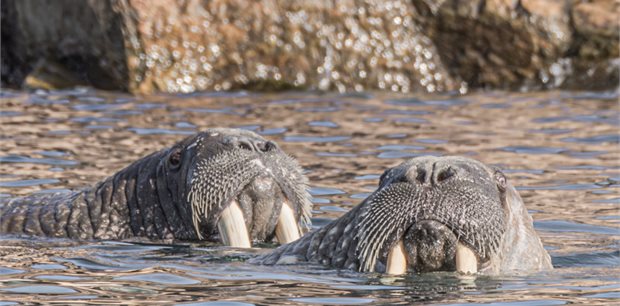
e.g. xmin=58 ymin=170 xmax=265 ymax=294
xmin=217 ymin=200 xmax=252 ymax=248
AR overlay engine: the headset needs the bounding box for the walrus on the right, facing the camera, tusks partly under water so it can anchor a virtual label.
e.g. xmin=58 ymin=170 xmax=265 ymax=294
xmin=251 ymin=156 xmax=552 ymax=274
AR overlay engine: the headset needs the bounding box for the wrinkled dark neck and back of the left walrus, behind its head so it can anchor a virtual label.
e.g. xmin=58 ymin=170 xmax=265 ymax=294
xmin=0 ymin=151 xmax=197 ymax=240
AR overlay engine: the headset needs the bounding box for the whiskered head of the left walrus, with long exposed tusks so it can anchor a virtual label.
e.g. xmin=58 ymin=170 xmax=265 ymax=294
xmin=163 ymin=128 xmax=311 ymax=247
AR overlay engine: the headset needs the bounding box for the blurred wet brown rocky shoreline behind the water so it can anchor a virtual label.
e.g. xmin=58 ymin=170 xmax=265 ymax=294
xmin=1 ymin=0 xmax=620 ymax=93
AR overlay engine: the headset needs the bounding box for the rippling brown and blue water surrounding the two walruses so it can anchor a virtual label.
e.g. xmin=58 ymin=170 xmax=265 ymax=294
xmin=0 ymin=89 xmax=620 ymax=305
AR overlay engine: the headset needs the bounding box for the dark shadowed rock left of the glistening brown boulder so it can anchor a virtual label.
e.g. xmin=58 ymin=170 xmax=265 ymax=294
xmin=2 ymin=0 xmax=127 ymax=90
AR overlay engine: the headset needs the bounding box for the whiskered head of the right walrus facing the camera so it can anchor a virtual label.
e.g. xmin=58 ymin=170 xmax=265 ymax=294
xmin=358 ymin=156 xmax=507 ymax=272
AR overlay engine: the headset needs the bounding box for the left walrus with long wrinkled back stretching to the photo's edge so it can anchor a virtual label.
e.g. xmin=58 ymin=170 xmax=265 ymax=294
xmin=0 ymin=129 xmax=311 ymax=247
